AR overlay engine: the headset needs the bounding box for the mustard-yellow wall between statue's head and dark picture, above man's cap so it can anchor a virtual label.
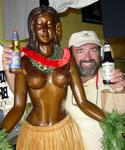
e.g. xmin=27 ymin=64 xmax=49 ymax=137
xmin=60 ymin=9 xmax=103 ymax=47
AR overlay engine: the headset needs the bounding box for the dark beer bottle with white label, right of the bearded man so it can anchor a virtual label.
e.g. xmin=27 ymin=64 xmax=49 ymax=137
xmin=102 ymin=42 xmax=115 ymax=84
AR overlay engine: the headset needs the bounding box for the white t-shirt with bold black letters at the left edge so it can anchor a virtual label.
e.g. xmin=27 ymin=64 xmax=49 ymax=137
xmin=0 ymin=45 xmax=14 ymax=123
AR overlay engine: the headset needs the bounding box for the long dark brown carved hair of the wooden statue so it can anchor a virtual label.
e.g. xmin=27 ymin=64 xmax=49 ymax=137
xmin=27 ymin=5 xmax=60 ymax=51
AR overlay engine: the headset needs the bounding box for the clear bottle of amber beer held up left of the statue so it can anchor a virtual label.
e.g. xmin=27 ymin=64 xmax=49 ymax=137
xmin=9 ymin=30 xmax=21 ymax=73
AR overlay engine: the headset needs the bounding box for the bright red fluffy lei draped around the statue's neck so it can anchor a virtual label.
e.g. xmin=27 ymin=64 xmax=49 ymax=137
xmin=21 ymin=47 xmax=70 ymax=68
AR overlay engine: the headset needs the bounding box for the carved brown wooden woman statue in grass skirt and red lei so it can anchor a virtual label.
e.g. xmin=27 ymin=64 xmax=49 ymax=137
xmin=1 ymin=6 xmax=104 ymax=150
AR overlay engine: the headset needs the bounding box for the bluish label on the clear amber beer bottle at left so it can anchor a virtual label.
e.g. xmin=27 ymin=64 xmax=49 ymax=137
xmin=9 ymin=51 xmax=21 ymax=69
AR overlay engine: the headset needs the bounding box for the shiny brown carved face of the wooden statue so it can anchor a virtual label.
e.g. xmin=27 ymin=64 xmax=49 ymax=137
xmin=34 ymin=12 xmax=56 ymax=44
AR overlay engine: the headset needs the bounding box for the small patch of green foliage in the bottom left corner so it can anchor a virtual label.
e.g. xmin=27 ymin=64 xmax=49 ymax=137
xmin=0 ymin=130 xmax=13 ymax=150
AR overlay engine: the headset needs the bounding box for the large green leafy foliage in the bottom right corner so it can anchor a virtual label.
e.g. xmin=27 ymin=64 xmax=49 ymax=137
xmin=100 ymin=110 xmax=125 ymax=150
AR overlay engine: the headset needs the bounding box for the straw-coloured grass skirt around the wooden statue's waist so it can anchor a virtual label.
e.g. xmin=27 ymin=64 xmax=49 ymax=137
xmin=16 ymin=115 xmax=84 ymax=150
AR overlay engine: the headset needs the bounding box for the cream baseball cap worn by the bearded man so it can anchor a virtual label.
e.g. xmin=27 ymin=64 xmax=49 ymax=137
xmin=69 ymin=30 xmax=102 ymax=47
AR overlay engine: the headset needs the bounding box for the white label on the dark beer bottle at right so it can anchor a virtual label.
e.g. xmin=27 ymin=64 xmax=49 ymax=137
xmin=102 ymin=62 xmax=115 ymax=81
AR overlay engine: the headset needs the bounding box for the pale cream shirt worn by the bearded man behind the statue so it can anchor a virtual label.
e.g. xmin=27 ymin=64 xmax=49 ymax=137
xmin=65 ymin=70 xmax=109 ymax=150
